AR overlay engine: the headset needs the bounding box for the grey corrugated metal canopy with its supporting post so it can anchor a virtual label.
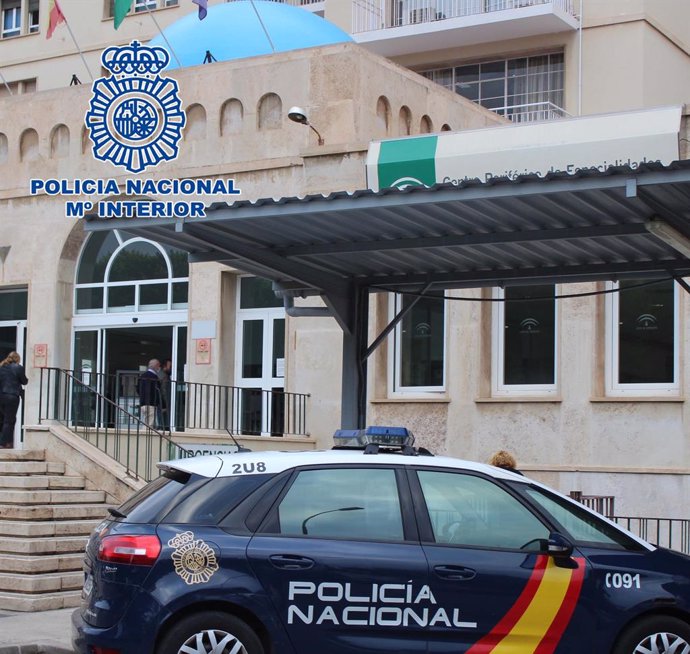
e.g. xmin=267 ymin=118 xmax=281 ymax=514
xmin=86 ymin=161 xmax=690 ymax=428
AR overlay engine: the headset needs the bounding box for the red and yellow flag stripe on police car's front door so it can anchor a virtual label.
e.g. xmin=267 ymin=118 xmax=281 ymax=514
xmin=468 ymin=555 xmax=585 ymax=654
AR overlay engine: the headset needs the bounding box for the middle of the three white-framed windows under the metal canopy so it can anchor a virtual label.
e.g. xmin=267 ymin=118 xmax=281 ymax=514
xmin=492 ymin=284 xmax=558 ymax=395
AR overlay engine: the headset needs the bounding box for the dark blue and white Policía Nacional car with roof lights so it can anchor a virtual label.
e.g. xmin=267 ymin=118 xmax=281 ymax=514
xmin=73 ymin=427 xmax=690 ymax=654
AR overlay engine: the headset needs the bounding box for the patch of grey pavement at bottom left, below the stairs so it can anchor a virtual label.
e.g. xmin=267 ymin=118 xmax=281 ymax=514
xmin=0 ymin=609 xmax=74 ymax=654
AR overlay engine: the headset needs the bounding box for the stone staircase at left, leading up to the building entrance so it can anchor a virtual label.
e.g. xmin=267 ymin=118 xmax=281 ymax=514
xmin=0 ymin=450 xmax=111 ymax=611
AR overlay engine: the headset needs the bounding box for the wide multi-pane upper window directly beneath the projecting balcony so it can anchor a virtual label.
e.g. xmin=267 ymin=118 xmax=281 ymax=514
xmin=422 ymin=52 xmax=565 ymax=122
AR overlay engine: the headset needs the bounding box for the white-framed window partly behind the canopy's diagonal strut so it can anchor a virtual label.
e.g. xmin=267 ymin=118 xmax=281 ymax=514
xmin=389 ymin=293 xmax=446 ymax=394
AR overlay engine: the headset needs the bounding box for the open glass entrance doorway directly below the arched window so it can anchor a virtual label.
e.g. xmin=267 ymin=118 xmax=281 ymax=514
xmin=72 ymin=325 xmax=187 ymax=431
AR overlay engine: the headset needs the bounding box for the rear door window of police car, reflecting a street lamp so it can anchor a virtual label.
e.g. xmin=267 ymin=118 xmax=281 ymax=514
xmin=261 ymin=468 xmax=404 ymax=540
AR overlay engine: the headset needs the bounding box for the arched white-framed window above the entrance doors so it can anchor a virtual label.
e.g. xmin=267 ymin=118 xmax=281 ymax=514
xmin=74 ymin=230 xmax=189 ymax=314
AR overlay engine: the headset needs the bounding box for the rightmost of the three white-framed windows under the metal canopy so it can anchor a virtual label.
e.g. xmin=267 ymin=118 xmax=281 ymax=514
xmin=606 ymin=280 xmax=680 ymax=396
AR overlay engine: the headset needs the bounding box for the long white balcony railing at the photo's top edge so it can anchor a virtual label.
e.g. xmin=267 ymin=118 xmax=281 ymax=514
xmin=352 ymin=0 xmax=576 ymax=34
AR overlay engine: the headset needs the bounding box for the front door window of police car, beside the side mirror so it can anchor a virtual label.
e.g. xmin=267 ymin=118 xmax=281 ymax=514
xmin=417 ymin=470 xmax=549 ymax=551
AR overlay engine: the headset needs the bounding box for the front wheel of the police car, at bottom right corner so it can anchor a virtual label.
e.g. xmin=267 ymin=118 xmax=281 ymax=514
xmin=613 ymin=616 xmax=690 ymax=654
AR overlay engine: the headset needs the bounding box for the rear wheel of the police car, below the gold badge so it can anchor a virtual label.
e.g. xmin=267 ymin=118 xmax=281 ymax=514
xmin=156 ymin=611 xmax=264 ymax=654
